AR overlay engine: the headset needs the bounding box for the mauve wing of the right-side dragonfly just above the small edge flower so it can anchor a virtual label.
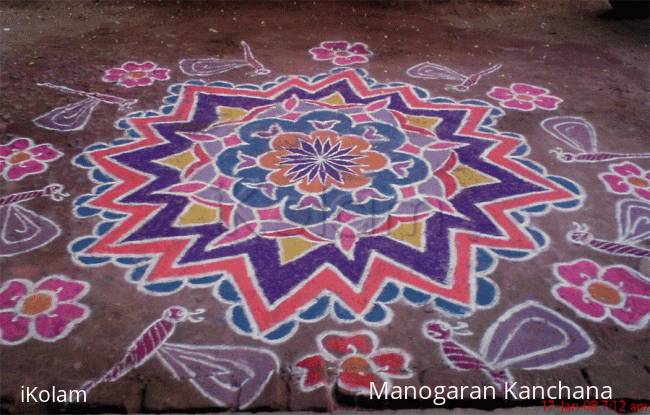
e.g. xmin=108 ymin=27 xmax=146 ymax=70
xmin=542 ymin=117 xmax=597 ymax=153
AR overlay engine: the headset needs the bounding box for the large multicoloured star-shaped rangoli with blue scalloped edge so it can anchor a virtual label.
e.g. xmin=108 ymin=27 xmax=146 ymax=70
xmin=69 ymin=68 xmax=584 ymax=342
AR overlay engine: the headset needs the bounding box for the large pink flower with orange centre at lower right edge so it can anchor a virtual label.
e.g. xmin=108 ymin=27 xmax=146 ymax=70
xmin=552 ymin=259 xmax=650 ymax=330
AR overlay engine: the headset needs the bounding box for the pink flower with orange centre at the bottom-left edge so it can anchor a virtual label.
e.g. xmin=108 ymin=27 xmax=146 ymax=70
xmin=0 ymin=275 xmax=90 ymax=345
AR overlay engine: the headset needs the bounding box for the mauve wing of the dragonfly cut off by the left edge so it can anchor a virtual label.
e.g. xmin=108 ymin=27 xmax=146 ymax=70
xmin=0 ymin=205 xmax=61 ymax=257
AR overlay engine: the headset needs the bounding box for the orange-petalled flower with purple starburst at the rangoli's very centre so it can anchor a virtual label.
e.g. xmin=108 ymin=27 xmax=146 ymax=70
xmin=260 ymin=131 xmax=388 ymax=193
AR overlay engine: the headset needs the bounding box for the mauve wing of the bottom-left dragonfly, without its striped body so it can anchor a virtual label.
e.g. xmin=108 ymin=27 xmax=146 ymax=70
xmin=158 ymin=344 xmax=279 ymax=408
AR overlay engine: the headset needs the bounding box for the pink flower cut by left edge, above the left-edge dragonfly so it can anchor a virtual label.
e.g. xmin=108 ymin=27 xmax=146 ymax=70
xmin=0 ymin=137 xmax=63 ymax=180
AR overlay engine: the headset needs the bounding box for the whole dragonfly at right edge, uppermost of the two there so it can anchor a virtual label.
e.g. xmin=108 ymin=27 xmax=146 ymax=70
xmin=541 ymin=116 xmax=650 ymax=163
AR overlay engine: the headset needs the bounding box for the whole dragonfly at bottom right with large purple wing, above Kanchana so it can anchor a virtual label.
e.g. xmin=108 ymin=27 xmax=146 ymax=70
xmin=422 ymin=301 xmax=595 ymax=391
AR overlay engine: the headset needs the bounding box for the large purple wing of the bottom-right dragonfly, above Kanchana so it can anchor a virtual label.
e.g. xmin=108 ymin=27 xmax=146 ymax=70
xmin=481 ymin=301 xmax=595 ymax=369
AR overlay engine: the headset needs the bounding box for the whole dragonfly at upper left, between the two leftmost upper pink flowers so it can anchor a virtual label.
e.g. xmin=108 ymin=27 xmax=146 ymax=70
xmin=32 ymin=82 xmax=138 ymax=131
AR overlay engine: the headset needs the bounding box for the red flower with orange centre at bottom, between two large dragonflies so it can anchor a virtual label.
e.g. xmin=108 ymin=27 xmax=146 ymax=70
xmin=296 ymin=331 xmax=411 ymax=394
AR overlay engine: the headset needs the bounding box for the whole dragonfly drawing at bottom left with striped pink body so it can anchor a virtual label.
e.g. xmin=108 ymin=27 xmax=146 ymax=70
xmin=81 ymin=306 xmax=279 ymax=408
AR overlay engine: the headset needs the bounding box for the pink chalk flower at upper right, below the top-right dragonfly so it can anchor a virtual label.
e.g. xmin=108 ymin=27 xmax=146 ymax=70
xmin=487 ymin=84 xmax=562 ymax=111
